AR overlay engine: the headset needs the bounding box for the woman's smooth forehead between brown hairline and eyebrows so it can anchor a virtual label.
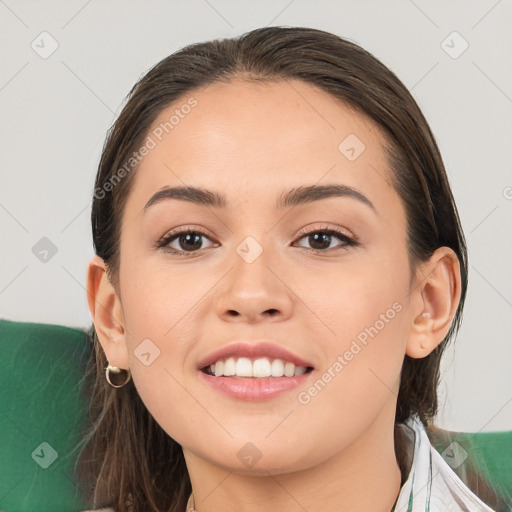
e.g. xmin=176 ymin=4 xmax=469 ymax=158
xmin=124 ymin=79 xmax=396 ymax=216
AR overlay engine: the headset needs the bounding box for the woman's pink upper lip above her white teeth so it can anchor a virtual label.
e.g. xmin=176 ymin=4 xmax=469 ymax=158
xmin=198 ymin=341 xmax=313 ymax=369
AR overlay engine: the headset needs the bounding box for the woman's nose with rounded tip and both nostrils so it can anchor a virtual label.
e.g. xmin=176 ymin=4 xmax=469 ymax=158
xmin=215 ymin=244 xmax=294 ymax=323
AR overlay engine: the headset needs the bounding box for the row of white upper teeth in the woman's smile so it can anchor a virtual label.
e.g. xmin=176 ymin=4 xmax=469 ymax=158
xmin=210 ymin=357 xmax=306 ymax=378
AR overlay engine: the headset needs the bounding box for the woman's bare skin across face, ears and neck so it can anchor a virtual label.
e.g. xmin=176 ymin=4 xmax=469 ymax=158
xmin=88 ymin=79 xmax=461 ymax=512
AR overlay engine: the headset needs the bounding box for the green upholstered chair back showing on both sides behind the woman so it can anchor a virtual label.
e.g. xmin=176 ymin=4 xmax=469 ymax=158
xmin=0 ymin=320 xmax=512 ymax=512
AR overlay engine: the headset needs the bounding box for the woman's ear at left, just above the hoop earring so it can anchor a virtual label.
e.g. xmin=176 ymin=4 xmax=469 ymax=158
xmin=87 ymin=256 xmax=130 ymax=369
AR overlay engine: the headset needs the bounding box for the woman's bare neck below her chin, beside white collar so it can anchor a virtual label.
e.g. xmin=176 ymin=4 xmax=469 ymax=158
xmin=185 ymin=408 xmax=402 ymax=512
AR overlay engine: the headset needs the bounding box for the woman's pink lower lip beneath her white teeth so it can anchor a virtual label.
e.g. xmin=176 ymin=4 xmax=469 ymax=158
xmin=199 ymin=370 xmax=313 ymax=401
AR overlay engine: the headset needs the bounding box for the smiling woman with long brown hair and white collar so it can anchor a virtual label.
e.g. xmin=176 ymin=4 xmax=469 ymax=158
xmin=77 ymin=27 xmax=508 ymax=512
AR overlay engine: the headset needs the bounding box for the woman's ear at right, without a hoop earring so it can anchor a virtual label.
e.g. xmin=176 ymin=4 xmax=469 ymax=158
xmin=406 ymin=247 xmax=461 ymax=358
